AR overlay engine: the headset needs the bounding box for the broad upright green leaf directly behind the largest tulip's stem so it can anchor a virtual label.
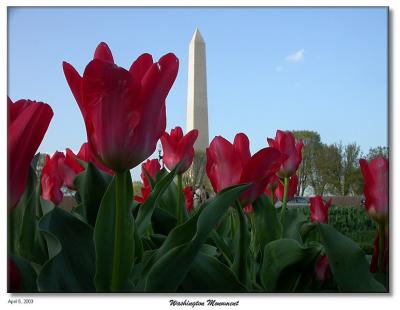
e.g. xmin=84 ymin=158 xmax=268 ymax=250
xmin=94 ymin=170 xmax=136 ymax=292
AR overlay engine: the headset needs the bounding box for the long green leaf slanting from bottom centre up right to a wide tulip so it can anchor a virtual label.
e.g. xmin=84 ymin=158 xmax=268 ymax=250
xmin=145 ymin=185 xmax=248 ymax=291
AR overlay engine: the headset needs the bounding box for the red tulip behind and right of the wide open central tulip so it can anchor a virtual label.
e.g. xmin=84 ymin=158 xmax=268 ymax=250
xmin=267 ymin=130 xmax=303 ymax=178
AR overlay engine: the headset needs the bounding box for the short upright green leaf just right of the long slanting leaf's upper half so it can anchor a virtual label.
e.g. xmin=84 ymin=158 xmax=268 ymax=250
xmin=252 ymin=194 xmax=287 ymax=250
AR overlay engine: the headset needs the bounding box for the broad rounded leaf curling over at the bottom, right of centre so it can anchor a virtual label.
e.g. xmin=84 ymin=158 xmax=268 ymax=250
xmin=260 ymin=239 xmax=321 ymax=292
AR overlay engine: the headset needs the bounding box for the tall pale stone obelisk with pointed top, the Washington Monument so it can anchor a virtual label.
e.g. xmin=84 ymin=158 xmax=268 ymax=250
xmin=186 ymin=29 xmax=208 ymax=152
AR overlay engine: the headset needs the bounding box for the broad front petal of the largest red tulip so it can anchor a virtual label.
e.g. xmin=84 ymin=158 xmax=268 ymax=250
xmin=82 ymin=59 xmax=140 ymax=171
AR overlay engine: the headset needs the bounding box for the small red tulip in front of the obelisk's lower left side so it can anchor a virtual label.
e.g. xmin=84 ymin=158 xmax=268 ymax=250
xmin=161 ymin=127 xmax=199 ymax=174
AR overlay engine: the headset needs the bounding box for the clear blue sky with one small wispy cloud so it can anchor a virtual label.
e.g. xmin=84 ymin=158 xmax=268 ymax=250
xmin=8 ymin=8 xmax=388 ymax=179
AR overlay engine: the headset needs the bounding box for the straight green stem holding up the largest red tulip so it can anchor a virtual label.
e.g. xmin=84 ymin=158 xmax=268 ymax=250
xmin=111 ymin=172 xmax=124 ymax=292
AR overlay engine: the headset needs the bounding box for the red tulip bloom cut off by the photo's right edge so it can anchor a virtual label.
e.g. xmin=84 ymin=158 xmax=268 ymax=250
xmin=360 ymin=156 xmax=389 ymax=222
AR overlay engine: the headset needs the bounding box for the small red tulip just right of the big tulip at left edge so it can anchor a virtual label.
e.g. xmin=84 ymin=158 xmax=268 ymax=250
xmin=41 ymin=152 xmax=65 ymax=205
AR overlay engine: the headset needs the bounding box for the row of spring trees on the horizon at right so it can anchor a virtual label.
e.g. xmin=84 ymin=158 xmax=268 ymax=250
xmin=293 ymin=130 xmax=389 ymax=196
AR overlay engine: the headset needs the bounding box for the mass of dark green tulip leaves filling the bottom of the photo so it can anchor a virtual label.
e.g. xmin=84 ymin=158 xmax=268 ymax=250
xmin=9 ymin=155 xmax=389 ymax=292
